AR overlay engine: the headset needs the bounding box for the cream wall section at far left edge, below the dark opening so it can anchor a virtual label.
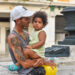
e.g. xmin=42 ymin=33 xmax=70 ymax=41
xmin=0 ymin=22 xmax=9 ymax=54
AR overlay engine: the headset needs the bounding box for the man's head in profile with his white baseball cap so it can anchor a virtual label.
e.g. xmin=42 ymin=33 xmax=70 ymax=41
xmin=10 ymin=6 xmax=35 ymax=26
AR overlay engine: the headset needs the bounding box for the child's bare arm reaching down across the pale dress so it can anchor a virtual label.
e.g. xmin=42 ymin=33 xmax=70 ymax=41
xmin=26 ymin=31 xmax=46 ymax=49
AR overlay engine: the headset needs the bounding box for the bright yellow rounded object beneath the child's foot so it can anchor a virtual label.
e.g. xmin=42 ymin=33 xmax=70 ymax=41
xmin=42 ymin=65 xmax=57 ymax=75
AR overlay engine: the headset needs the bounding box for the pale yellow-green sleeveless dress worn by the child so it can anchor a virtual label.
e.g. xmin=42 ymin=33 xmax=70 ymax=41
xmin=29 ymin=30 xmax=45 ymax=57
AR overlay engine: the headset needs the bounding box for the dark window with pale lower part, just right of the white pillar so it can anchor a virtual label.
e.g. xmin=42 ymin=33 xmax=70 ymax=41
xmin=55 ymin=15 xmax=67 ymax=43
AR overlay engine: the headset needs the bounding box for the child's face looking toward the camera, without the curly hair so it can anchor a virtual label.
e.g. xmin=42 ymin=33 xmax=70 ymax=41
xmin=33 ymin=17 xmax=44 ymax=30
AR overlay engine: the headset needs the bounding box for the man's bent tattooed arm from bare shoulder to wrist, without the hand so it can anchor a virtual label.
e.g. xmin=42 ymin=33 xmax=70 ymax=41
xmin=8 ymin=35 xmax=35 ymax=68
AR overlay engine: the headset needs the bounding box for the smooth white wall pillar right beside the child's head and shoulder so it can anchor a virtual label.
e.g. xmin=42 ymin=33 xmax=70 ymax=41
xmin=44 ymin=17 xmax=55 ymax=47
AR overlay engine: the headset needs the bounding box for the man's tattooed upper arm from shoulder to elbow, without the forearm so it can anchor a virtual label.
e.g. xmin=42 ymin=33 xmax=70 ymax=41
xmin=8 ymin=36 xmax=25 ymax=63
